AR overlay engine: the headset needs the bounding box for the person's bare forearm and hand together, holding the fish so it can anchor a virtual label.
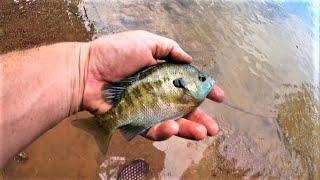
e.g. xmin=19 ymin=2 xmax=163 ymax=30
xmin=0 ymin=31 xmax=224 ymax=169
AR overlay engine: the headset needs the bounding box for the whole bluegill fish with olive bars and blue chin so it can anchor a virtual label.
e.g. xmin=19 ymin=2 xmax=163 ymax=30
xmin=74 ymin=62 xmax=215 ymax=152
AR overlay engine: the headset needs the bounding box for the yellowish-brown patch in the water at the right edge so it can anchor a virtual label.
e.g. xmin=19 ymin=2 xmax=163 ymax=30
xmin=277 ymin=83 xmax=320 ymax=179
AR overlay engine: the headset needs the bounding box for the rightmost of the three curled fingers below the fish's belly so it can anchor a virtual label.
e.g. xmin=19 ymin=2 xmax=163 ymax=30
xmin=186 ymin=109 xmax=219 ymax=136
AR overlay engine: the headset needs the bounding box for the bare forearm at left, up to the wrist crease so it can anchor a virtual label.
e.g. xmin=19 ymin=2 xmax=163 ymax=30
xmin=0 ymin=43 xmax=89 ymax=169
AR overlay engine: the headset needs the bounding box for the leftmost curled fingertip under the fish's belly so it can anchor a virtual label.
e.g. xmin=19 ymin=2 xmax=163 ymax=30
xmin=146 ymin=120 xmax=179 ymax=141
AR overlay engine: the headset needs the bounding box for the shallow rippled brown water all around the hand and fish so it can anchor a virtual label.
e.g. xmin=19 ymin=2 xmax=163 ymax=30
xmin=0 ymin=0 xmax=320 ymax=179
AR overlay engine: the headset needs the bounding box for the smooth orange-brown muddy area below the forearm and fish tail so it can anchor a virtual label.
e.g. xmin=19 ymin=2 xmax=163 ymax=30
xmin=2 ymin=112 xmax=165 ymax=179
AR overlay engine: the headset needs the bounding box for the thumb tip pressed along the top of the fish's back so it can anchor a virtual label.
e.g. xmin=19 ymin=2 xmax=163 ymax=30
xmin=153 ymin=36 xmax=192 ymax=63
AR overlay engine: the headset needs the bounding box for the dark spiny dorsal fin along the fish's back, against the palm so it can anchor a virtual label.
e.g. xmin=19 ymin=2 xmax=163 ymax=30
xmin=102 ymin=65 xmax=156 ymax=104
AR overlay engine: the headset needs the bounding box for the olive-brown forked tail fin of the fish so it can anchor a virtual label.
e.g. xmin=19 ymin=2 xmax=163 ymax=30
xmin=71 ymin=117 xmax=114 ymax=154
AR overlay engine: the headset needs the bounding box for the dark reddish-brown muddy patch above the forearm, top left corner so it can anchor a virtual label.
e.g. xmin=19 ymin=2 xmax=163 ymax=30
xmin=0 ymin=0 xmax=93 ymax=53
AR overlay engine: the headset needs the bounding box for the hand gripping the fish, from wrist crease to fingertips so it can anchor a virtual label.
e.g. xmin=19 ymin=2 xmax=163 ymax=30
xmin=82 ymin=31 xmax=224 ymax=140
